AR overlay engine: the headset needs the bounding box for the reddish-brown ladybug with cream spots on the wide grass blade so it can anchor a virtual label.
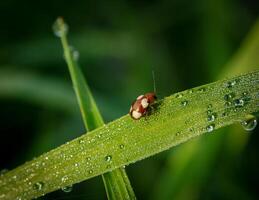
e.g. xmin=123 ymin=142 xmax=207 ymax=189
xmin=129 ymin=92 xmax=157 ymax=120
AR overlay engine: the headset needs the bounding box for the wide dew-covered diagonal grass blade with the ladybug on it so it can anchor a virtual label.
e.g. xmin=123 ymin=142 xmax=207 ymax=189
xmin=0 ymin=71 xmax=259 ymax=200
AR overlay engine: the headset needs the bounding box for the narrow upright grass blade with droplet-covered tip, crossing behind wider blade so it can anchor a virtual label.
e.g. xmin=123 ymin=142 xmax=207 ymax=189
xmin=54 ymin=18 xmax=136 ymax=200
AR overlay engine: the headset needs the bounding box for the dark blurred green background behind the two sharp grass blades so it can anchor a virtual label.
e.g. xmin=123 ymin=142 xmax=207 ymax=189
xmin=0 ymin=0 xmax=259 ymax=200
